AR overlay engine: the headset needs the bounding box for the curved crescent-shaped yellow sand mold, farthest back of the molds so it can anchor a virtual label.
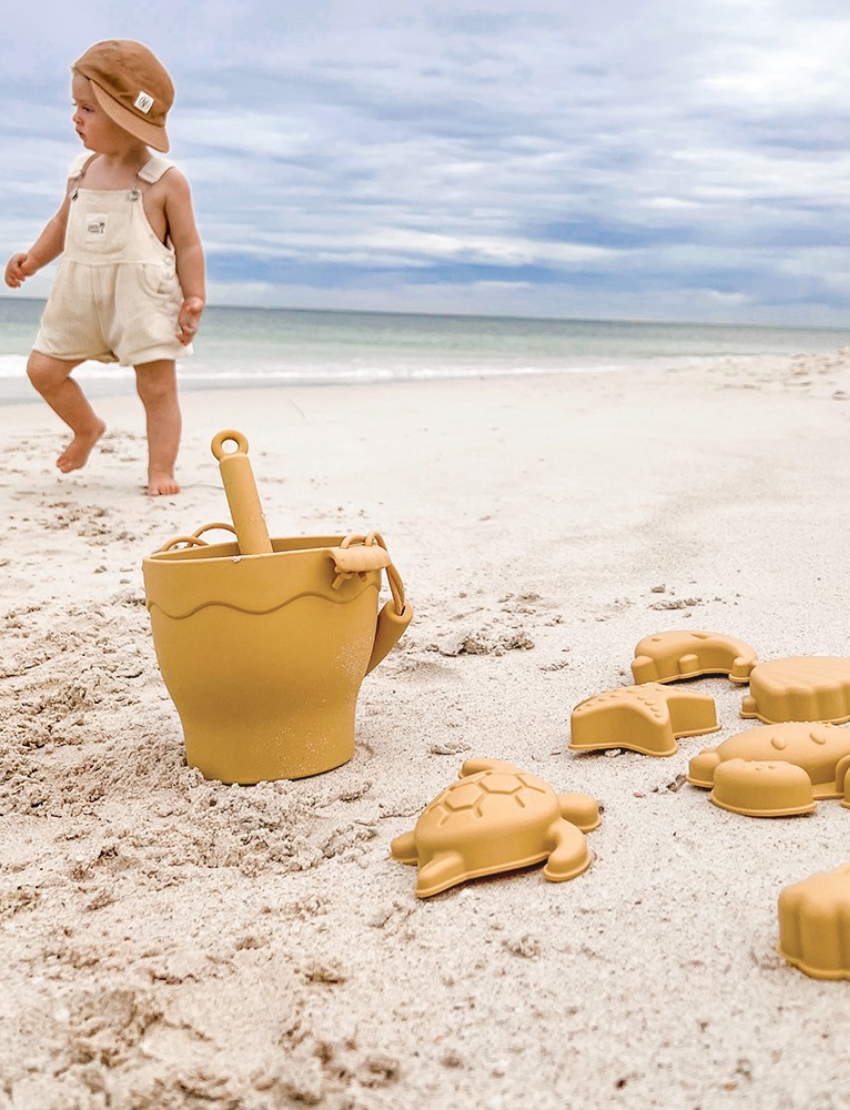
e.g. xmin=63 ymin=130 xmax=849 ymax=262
xmin=631 ymin=630 xmax=758 ymax=683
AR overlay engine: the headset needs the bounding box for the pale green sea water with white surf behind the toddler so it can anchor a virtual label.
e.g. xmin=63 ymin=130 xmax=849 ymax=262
xmin=0 ymin=296 xmax=850 ymax=404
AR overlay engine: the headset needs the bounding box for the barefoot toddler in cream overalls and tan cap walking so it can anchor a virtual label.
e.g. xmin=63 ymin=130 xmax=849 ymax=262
xmin=6 ymin=39 xmax=204 ymax=497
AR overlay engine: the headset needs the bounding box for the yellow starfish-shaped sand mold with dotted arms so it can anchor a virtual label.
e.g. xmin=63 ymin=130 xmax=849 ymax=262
xmin=569 ymin=683 xmax=720 ymax=756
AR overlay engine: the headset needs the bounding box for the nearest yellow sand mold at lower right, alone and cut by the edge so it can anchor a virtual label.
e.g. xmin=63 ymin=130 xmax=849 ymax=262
xmin=777 ymin=864 xmax=850 ymax=979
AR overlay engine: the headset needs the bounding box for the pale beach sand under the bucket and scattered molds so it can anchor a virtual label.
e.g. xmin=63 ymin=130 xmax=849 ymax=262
xmin=0 ymin=354 xmax=850 ymax=1110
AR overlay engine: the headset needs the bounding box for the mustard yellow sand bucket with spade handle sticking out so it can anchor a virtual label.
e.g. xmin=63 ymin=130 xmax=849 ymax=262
xmin=143 ymin=431 xmax=413 ymax=784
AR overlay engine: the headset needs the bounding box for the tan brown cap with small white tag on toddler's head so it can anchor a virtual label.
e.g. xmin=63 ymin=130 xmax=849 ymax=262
xmin=72 ymin=39 xmax=174 ymax=151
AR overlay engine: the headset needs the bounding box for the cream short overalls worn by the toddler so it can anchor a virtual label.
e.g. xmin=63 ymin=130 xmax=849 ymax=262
xmin=33 ymin=153 xmax=192 ymax=366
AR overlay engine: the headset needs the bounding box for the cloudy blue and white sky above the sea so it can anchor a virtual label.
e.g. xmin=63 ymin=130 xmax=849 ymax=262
xmin=0 ymin=0 xmax=850 ymax=326
